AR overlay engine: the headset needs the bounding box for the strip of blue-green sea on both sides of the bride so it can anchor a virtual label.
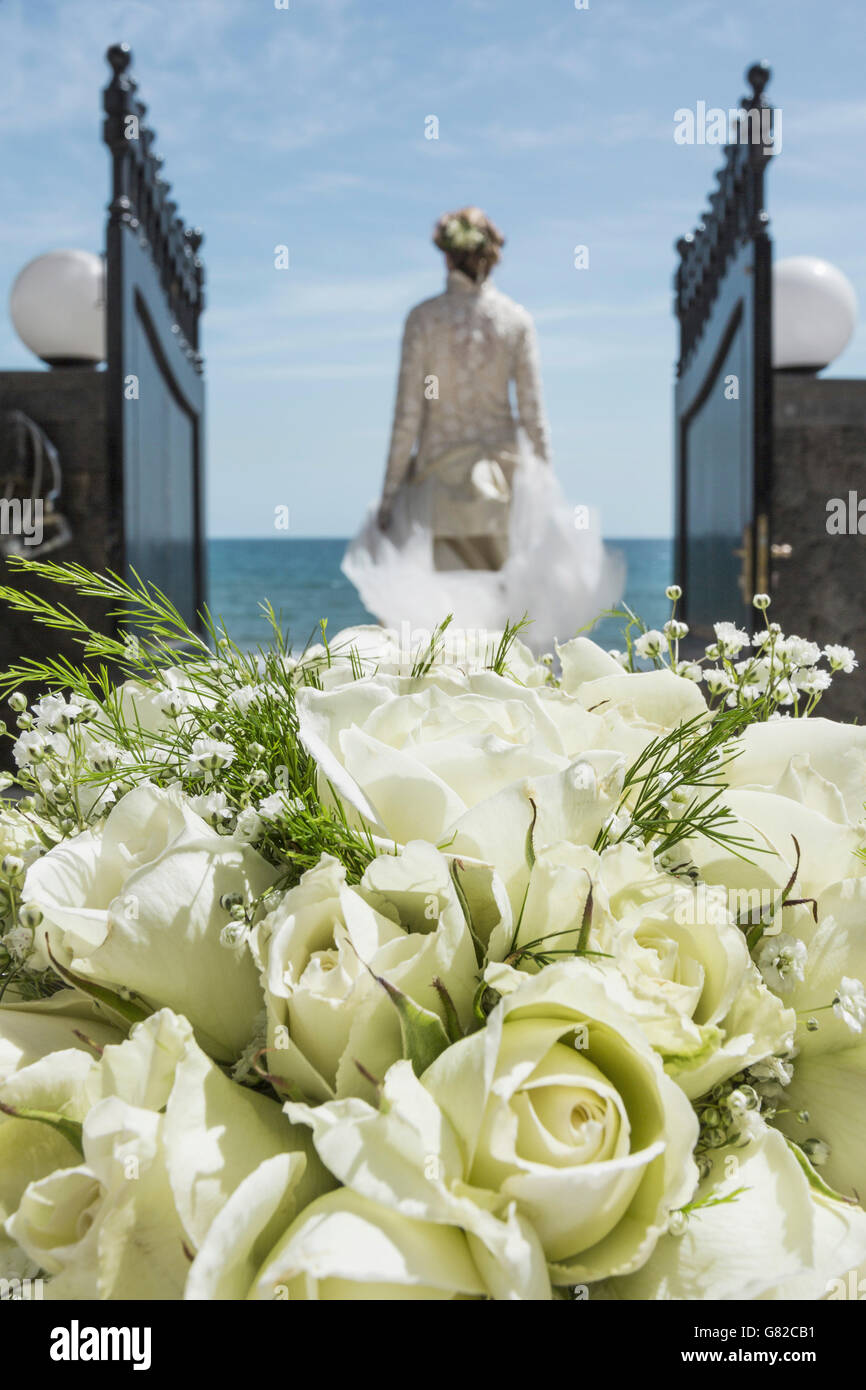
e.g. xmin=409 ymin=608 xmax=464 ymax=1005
xmin=207 ymin=537 xmax=673 ymax=651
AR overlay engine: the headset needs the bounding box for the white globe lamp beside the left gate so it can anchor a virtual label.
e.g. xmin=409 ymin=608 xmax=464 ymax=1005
xmin=10 ymin=250 xmax=106 ymax=367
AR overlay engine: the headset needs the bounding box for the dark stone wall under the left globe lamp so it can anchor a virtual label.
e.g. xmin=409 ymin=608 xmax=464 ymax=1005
xmin=0 ymin=367 xmax=121 ymax=683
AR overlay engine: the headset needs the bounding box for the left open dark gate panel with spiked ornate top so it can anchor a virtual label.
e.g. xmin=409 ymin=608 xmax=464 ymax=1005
xmin=104 ymin=44 xmax=206 ymax=623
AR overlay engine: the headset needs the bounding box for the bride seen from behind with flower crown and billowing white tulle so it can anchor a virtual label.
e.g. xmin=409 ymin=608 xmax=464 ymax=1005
xmin=342 ymin=207 xmax=624 ymax=652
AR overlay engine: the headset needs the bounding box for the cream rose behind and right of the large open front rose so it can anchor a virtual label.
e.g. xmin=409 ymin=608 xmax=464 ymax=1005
xmin=494 ymin=842 xmax=795 ymax=1098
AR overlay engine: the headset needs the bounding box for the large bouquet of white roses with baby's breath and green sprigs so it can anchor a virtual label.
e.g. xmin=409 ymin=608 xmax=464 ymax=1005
xmin=0 ymin=562 xmax=866 ymax=1300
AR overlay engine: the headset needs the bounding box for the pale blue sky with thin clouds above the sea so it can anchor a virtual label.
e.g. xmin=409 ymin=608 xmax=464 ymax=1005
xmin=0 ymin=0 xmax=866 ymax=537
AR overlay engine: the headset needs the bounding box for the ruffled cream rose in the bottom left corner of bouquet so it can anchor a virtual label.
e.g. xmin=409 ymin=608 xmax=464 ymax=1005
xmin=0 ymin=1009 xmax=328 ymax=1300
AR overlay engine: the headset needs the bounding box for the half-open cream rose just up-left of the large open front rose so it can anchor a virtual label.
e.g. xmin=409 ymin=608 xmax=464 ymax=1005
xmin=253 ymin=841 xmax=477 ymax=1101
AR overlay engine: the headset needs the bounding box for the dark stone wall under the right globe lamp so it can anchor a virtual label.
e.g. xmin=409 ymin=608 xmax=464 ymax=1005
xmin=770 ymin=373 xmax=866 ymax=723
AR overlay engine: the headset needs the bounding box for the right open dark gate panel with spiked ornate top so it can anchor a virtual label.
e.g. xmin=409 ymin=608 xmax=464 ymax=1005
xmin=674 ymin=64 xmax=773 ymax=637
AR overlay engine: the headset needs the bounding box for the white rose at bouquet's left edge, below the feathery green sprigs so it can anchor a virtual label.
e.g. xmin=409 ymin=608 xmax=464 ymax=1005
xmin=24 ymin=785 xmax=277 ymax=1058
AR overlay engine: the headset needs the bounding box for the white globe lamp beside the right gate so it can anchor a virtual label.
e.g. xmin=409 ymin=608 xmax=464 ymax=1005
xmin=773 ymin=256 xmax=858 ymax=373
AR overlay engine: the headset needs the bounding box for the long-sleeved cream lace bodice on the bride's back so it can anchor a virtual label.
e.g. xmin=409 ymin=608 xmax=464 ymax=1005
xmin=384 ymin=270 xmax=549 ymax=496
